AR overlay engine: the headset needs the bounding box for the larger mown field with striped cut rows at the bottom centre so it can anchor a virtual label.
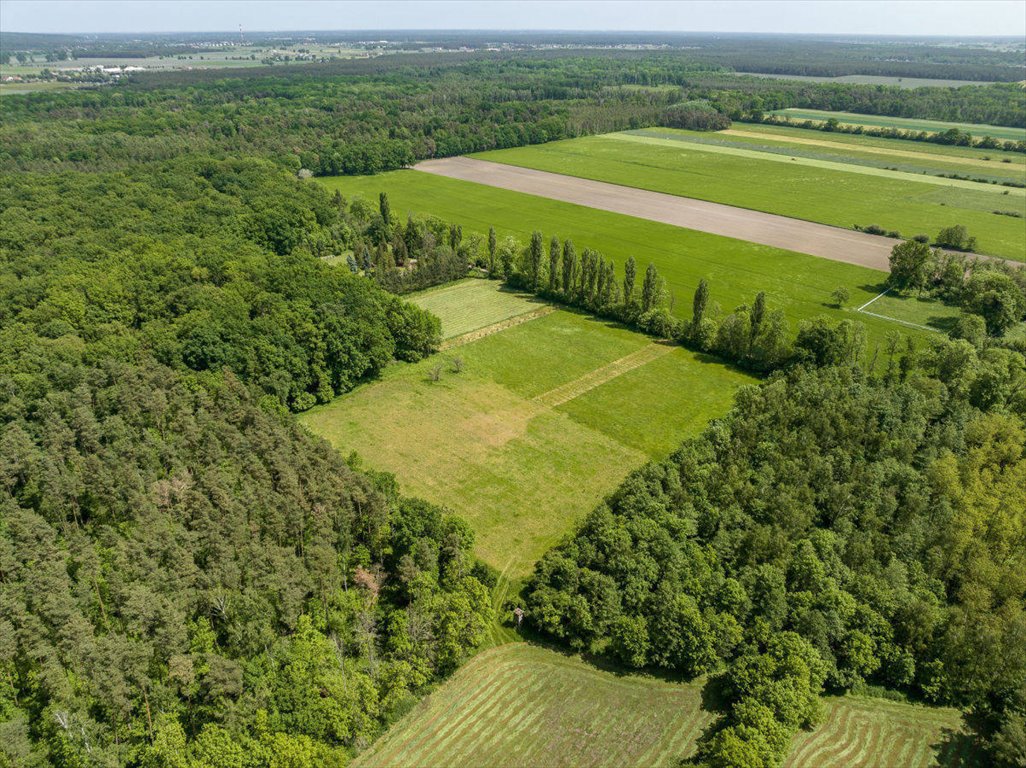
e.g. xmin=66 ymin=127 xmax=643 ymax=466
xmin=355 ymin=643 xmax=711 ymax=766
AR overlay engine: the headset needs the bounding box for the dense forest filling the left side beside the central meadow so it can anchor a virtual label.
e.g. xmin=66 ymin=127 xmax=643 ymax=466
xmin=0 ymin=153 xmax=491 ymax=768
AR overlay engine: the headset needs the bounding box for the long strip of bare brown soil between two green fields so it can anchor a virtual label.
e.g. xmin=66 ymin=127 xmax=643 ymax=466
xmin=413 ymin=157 xmax=915 ymax=272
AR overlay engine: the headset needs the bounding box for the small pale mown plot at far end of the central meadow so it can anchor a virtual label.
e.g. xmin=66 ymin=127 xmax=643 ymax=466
xmin=408 ymin=280 xmax=543 ymax=338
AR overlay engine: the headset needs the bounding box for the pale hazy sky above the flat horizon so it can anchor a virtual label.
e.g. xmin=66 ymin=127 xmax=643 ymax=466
xmin=0 ymin=0 xmax=1026 ymax=37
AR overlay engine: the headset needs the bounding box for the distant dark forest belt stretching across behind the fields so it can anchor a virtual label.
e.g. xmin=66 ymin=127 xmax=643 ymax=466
xmin=0 ymin=51 xmax=1026 ymax=174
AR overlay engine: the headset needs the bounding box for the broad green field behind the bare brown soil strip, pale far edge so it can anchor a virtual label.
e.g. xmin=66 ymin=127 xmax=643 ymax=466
xmin=474 ymin=128 xmax=1026 ymax=261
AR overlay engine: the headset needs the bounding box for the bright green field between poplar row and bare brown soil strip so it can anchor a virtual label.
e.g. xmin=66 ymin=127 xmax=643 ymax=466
xmin=317 ymin=170 xmax=952 ymax=352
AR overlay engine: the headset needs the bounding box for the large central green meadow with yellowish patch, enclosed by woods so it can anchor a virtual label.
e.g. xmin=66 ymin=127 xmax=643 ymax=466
xmin=302 ymin=280 xmax=754 ymax=579
